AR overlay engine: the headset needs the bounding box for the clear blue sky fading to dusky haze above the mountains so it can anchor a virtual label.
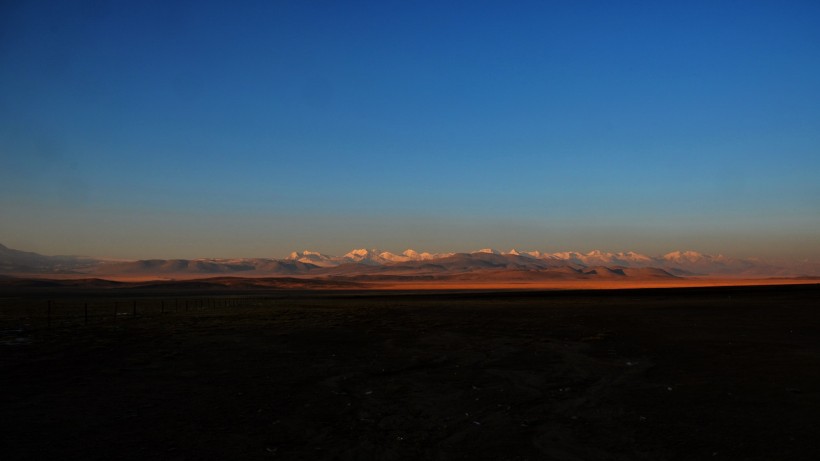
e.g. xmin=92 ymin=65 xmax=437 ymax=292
xmin=0 ymin=0 xmax=820 ymax=261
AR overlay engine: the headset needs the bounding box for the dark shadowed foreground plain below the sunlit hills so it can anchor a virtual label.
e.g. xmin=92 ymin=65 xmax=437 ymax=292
xmin=0 ymin=285 xmax=820 ymax=460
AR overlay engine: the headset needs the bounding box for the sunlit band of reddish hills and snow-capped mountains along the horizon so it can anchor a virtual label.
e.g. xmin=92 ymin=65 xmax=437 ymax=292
xmin=0 ymin=245 xmax=820 ymax=280
